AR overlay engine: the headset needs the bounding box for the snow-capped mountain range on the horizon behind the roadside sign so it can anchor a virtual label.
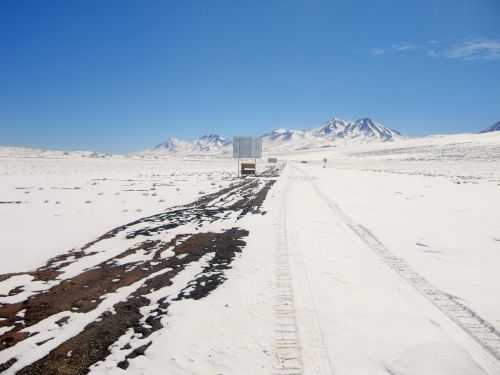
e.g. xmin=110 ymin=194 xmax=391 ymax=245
xmin=151 ymin=118 xmax=401 ymax=155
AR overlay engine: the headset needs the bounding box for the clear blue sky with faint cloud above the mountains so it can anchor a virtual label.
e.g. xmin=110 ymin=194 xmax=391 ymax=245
xmin=0 ymin=0 xmax=500 ymax=153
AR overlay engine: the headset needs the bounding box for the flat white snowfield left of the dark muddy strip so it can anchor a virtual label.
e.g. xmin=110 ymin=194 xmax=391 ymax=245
xmin=0 ymin=157 xmax=236 ymax=274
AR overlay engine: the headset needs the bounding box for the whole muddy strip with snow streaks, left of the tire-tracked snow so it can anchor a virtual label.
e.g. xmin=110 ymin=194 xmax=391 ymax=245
xmin=0 ymin=172 xmax=277 ymax=374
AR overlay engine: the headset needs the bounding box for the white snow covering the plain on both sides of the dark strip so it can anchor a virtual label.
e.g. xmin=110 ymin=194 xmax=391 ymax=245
xmin=0 ymin=132 xmax=500 ymax=375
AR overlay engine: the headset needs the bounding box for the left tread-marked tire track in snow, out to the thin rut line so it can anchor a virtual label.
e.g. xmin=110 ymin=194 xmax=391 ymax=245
xmin=274 ymin=169 xmax=333 ymax=375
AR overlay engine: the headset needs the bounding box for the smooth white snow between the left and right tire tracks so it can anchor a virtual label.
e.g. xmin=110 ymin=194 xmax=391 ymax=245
xmin=285 ymin=165 xmax=492 ymax=374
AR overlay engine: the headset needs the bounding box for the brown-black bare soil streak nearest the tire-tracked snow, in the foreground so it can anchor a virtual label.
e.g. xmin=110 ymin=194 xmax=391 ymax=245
xmin=17 ymin=228 xmax=248 ymax=375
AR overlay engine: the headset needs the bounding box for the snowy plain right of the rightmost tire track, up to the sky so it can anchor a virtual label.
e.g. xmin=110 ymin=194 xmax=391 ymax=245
xmin=282 ymin=132 xmax=500 ymax=328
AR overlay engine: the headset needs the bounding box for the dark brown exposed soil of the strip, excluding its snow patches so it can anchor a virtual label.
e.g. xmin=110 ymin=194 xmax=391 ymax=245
xmin=0 ymin=170 xmax=279 ymax=375
